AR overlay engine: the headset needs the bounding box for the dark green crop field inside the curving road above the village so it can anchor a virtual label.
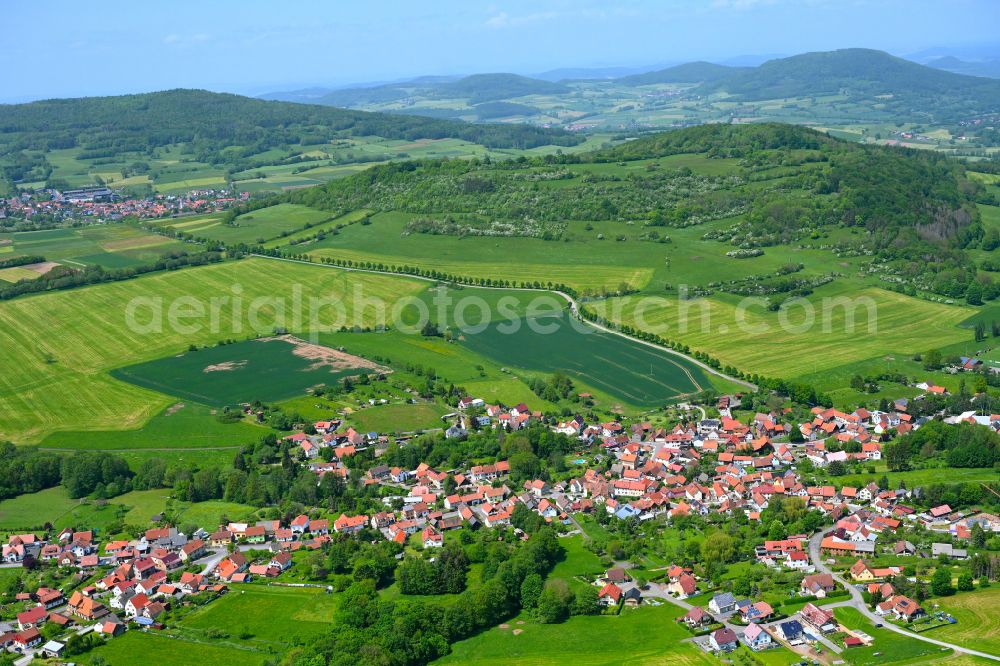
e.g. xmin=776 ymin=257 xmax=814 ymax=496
xmin=462 ymin=314 xmax=711 ymax=406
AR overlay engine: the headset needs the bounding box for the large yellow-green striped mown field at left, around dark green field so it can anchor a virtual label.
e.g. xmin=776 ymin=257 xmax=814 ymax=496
xmin=0 ymin=259 xmax=426 ymax=443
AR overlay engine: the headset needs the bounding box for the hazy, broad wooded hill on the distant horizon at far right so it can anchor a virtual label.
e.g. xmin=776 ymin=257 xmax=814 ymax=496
xmin=699 ymin=49 xmax=1000 ymax=119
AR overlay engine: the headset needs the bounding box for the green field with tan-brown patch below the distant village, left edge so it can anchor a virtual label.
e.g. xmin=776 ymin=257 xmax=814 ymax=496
xmin=0 ymin=224 xmax=192 ymax=268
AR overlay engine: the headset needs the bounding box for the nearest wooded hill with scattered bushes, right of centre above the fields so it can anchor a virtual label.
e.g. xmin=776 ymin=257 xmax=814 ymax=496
xmin=286 ymin=123 xmax=984 ymax=258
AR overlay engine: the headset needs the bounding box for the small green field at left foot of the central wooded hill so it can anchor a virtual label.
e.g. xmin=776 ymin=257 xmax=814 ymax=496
xmin=154 ymin=204 xmax=329 ymax=245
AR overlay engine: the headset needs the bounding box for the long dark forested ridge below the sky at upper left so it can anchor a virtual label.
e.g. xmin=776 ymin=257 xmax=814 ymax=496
xmin=0 ymin=89 xmax=582 ymax=150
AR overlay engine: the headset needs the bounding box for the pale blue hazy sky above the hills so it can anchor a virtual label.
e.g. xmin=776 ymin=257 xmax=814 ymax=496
xmin=0 ymin=0 xmax=1000 ymax=102
